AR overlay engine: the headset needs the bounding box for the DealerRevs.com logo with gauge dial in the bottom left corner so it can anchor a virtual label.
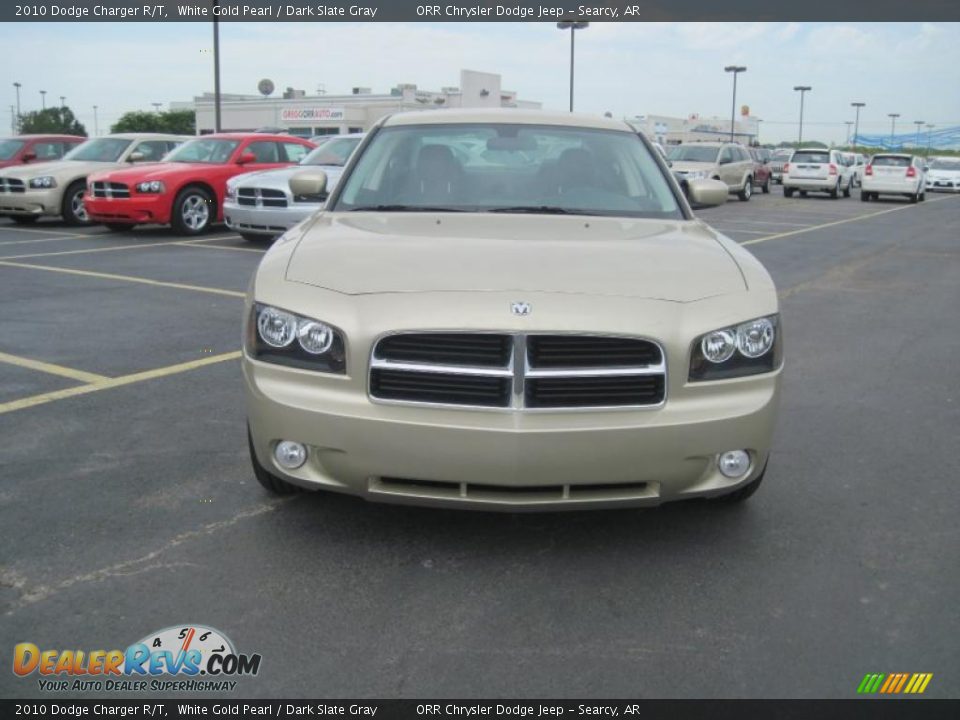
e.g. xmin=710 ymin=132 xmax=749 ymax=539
xmin=13 ymin=625 xmax=260 ymax=692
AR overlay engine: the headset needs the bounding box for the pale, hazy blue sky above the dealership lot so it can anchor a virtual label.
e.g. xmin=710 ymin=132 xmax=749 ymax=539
xmin=0 ymin=22 xmax=960 ymax=142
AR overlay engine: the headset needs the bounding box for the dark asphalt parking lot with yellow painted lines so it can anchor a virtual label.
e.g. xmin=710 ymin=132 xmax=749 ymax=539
xmin=0 ymin=188 xmax=960 ymax=698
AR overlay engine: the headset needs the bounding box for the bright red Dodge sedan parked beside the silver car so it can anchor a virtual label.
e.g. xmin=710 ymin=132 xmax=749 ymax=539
xmin=83 ymin=133 xmax=316 ymax=235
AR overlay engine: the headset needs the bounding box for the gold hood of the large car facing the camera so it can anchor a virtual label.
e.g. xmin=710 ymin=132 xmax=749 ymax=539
xmin=286 ymin=213 xmax=746 ymax=302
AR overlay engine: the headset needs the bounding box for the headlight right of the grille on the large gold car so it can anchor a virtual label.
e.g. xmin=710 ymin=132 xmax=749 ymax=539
xmin=689 ymin=315 xmax=783 ymax=381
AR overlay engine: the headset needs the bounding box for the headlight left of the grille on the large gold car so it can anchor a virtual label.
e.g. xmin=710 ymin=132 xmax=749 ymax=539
xmin=245 ymin=303 xmax=346 ymax=375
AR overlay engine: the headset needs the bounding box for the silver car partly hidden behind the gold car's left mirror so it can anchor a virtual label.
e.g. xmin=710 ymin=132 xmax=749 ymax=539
xmin=223 ymin=133 xmax=366 ymax=241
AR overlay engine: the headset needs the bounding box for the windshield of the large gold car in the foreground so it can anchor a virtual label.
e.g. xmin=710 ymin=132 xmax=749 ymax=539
xmin=332 ymin=123 xmax=683 ymax=218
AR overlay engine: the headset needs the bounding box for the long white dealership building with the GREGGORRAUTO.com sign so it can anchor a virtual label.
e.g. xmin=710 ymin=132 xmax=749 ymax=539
xmin=177 ymin=70 xmax=541 ymax=137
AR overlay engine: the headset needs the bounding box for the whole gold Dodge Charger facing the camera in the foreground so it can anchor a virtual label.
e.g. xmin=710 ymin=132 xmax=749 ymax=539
xmin=243 ymin=110 xmax=782 ymax=510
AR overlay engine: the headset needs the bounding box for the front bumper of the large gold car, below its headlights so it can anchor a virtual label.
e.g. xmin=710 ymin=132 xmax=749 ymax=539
xmin=242 ymin=290 xmax=781 ymax=510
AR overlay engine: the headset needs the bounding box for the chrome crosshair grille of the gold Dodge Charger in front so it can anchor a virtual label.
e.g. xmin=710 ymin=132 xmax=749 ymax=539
xmin=369 ymin=332 xmax=667 ymax=410
